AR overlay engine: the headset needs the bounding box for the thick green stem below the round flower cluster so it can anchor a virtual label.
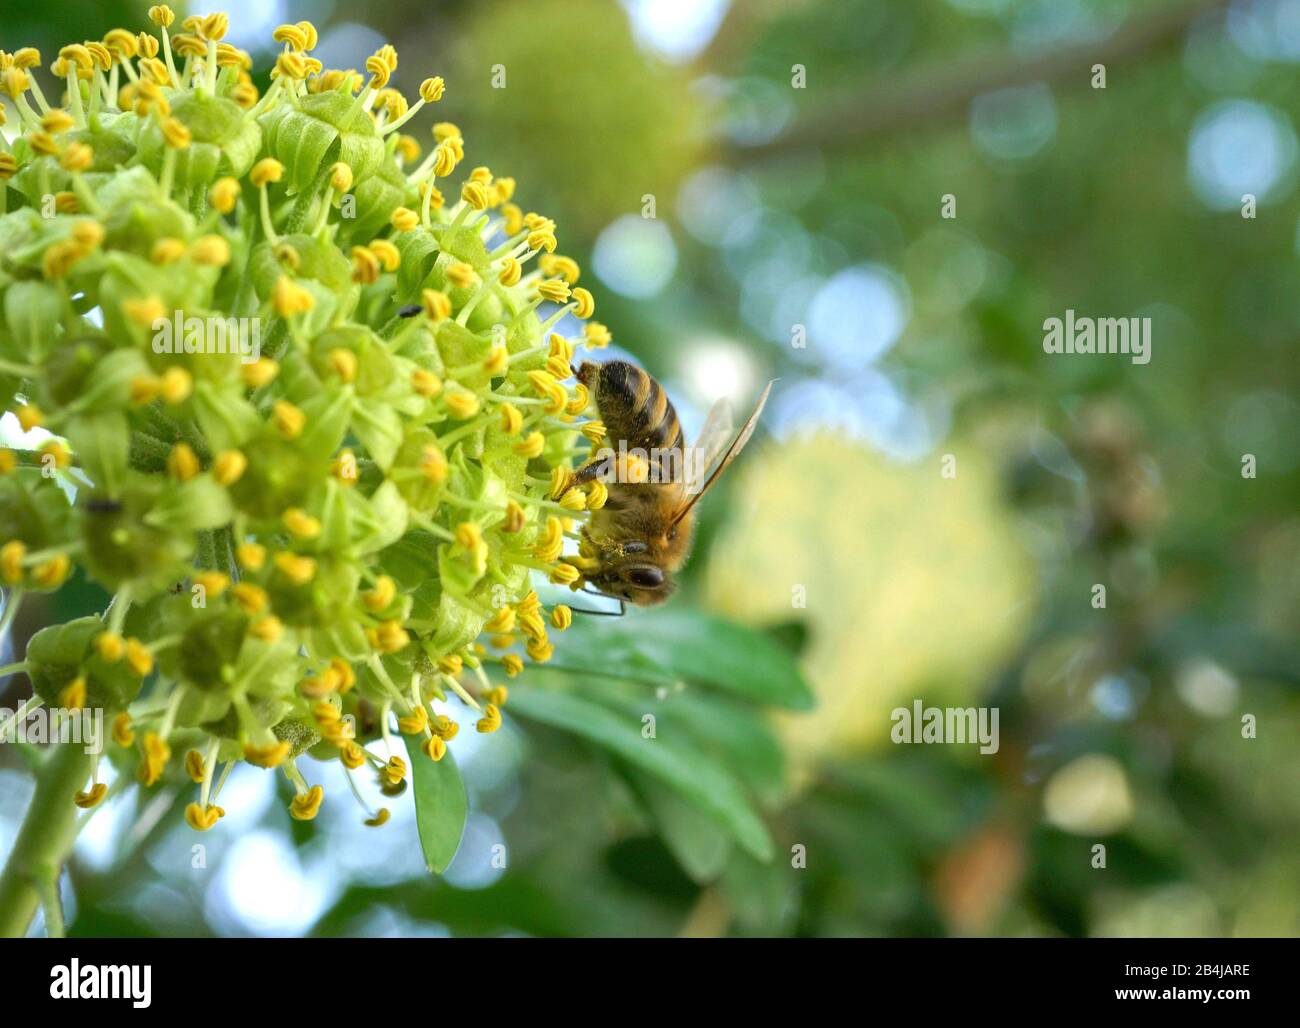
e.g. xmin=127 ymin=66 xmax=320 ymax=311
xmin=0 ymin=745 xmax=94 ymax=938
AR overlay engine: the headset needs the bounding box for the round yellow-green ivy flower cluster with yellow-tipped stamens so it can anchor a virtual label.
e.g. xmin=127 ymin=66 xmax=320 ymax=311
xmin=0 ymin=6 xmax=610 ymax=830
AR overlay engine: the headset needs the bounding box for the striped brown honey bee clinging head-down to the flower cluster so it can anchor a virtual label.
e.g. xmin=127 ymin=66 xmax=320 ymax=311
xmin=560 ymin=360 xmax=772 ymax=612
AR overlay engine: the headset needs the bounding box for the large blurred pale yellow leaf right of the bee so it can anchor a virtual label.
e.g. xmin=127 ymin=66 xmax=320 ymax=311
xmin=706 ymin=434 xmax=1035 ymax=768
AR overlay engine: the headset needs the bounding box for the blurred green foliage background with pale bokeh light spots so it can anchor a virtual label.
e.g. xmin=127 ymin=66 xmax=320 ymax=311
xmin=0 ymin=0 xmax=1300 ymax=936
